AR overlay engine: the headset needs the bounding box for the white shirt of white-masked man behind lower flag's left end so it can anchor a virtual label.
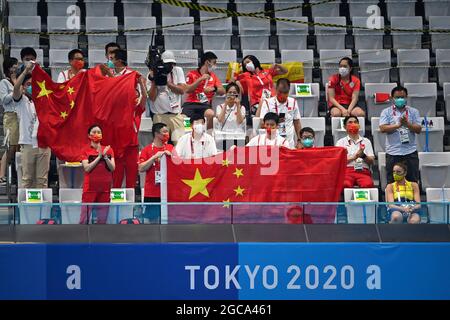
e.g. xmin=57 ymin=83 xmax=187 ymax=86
xmin=175 ymin=133 xmax=217 ymax=159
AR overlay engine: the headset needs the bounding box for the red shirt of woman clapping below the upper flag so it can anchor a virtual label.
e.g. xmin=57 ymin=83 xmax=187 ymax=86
xmin=81 ymin=146 xmax=114 ymax=192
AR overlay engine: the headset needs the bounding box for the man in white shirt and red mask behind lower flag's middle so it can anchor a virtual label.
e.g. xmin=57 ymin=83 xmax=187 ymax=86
xmin=247 ymin=112 xmax=289 ymax=148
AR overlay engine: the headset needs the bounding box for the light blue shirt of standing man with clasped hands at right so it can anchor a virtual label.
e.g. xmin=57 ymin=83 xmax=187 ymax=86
xmin=380 ymin=106 xmax=421 ymax=156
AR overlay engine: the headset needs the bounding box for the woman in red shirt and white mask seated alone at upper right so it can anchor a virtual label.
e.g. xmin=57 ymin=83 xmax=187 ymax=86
xmin=327 ymin=57 xmax=365 ymax=117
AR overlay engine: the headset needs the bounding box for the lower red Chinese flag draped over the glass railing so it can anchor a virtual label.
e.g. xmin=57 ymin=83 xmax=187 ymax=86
xmin=167 ymin=147 xmax=347 ymax=222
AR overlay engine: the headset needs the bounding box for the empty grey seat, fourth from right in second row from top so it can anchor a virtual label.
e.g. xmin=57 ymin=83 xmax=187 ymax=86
xmin=314 ymin=17 xmax=347 ymax=50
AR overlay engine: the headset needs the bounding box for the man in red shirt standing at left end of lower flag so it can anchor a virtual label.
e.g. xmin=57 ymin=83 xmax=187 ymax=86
xmin=139 ymin=123 xmax=173 ymax=223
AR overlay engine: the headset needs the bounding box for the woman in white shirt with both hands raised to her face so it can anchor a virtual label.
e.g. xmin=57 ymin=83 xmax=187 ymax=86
xmin=216 ymin=83 xmax=245 ymax=132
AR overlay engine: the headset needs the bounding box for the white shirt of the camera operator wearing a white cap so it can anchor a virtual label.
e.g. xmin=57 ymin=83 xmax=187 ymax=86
xmin=147 ymin=66 xmax=186 ymax=114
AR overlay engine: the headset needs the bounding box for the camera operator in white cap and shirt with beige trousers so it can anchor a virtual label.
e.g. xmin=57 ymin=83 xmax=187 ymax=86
xmin=147 ymin=51 xmax=186 ymax=145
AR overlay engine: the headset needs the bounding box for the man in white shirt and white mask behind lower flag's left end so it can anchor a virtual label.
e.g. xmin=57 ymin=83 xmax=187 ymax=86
xmin=175 ymin=113 xmax=217 ymax=159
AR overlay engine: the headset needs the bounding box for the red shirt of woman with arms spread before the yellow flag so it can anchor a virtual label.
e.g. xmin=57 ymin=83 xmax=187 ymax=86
xmin=237 ymin=68 xmax=275 ymax=106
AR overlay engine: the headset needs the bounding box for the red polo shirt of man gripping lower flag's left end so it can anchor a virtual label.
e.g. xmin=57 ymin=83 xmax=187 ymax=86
xmin=139 ymin=143 xmax=173 ymax=198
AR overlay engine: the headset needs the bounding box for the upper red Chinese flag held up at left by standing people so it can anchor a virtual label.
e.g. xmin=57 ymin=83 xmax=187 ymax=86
xmin=32 ymin=65 xmax=142 ymax=161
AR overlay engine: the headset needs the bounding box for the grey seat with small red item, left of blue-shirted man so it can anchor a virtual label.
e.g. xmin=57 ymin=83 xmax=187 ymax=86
xmin=364 ymin=83 xmax=397 ymax=120
